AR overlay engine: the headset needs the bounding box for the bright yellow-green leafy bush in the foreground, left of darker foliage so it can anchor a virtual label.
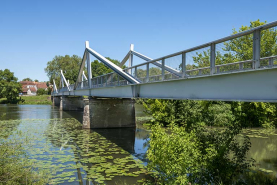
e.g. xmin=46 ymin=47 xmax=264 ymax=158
xmin=147 ymin=125 xmax=215 ymax=184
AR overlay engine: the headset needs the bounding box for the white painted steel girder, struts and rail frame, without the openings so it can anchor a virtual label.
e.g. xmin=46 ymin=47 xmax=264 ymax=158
xmin=52 ymin=21 xmax=277 ymax=102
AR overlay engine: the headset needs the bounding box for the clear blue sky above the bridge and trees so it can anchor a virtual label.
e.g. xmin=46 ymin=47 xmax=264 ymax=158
xmin=0 ymin=0 xmax=277 ymax=81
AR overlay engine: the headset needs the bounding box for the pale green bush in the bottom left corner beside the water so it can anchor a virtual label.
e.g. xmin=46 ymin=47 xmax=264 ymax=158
xmin=0 ymin=120 xmax=48 ymax=185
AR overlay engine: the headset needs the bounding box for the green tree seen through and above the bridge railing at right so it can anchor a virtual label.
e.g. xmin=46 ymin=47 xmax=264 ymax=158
xmin=191 ymin=19 xmax=277 ymax=71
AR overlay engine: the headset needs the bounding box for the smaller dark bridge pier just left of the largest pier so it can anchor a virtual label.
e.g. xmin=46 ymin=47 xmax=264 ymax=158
xmin=60 ymin=96 xmax=84 ymax=111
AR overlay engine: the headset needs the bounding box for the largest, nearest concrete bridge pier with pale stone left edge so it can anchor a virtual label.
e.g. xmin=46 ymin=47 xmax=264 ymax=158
xmin=83 ymin=98 xmax=136 ymax=128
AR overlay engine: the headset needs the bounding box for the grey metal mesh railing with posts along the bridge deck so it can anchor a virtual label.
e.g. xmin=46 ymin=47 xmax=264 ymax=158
xmin=54 ymin=21 xmax=277 ymax=92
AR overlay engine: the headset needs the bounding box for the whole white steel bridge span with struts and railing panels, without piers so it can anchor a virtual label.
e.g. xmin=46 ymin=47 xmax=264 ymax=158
xmin=52 ymin=21 xmax=277 ymax=102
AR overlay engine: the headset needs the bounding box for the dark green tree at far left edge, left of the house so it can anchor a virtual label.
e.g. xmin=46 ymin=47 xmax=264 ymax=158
xmin=0 ymin=69 xmax=22 ymax=102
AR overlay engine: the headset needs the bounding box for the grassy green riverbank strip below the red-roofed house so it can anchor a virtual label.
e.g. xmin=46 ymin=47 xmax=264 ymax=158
xmin=0 ymin=95 xmax=52 ymax=105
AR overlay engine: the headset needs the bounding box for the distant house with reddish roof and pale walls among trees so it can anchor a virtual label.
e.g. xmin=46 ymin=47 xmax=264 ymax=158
xmin=19 ymin=81 xmax=47 ymax=95
